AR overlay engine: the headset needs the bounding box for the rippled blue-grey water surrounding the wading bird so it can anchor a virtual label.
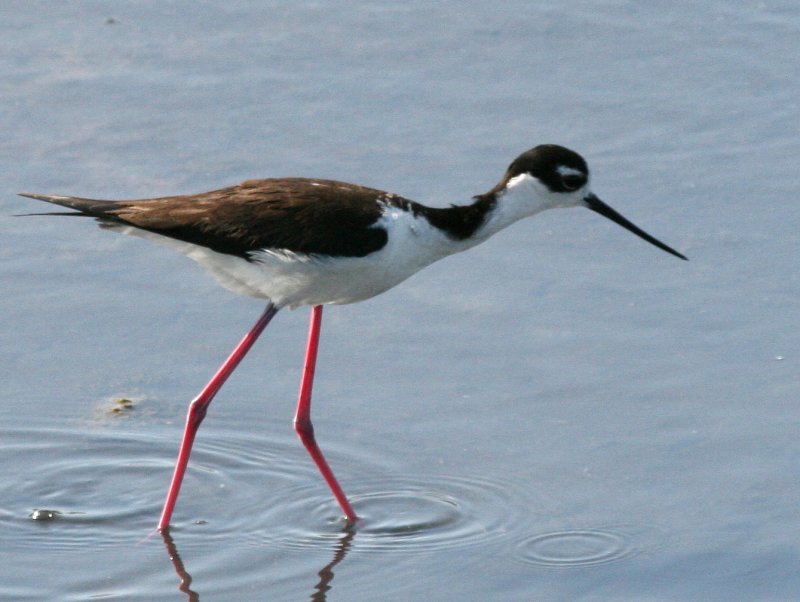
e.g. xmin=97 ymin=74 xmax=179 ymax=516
xmin=0 ymin=1 xmax=800 ymax=601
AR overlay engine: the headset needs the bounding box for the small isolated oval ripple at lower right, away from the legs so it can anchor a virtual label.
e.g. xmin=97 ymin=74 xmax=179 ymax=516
xmin=515 ymin=527 xmax=652 ymax=568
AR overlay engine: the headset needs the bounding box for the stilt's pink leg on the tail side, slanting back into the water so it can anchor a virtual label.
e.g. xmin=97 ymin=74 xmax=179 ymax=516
xmin=158 ymin=303 xmax=278 ymax=530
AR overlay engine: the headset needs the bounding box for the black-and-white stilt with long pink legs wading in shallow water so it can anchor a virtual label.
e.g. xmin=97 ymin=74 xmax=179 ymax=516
xmin=18 ymin=144 xmax=686 ymax=529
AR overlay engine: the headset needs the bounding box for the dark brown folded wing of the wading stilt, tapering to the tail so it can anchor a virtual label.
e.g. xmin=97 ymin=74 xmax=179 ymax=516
xmin=25 ymin=178 xmax=415 ymax=258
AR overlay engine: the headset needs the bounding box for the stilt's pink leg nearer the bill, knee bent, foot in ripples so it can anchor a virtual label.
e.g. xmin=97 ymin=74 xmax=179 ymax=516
xmin=294 ymin=305 xmax=358 ymax=522
